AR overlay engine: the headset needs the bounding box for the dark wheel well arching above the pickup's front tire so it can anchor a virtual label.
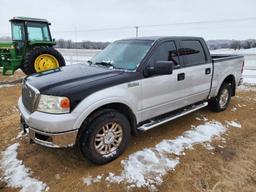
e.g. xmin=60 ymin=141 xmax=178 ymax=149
xmin=81 ymin=103 xmax=138 ymax=136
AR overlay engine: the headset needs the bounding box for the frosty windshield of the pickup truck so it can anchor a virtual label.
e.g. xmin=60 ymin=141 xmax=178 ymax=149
xmin=90 ymin=40 xmax=153 ymax=70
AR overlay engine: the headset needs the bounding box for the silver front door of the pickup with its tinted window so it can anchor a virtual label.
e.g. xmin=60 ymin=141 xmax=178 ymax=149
xmin=141 ymin=41 xmax=189 ymax=121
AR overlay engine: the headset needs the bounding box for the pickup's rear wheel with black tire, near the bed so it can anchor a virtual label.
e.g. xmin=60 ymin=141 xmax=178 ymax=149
xmin=209 ymin=83 xmax=231 ymax=112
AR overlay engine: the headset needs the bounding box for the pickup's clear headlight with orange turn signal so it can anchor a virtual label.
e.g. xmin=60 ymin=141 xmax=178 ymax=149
xmin=37 ymin=95 xmax=70 ymax=113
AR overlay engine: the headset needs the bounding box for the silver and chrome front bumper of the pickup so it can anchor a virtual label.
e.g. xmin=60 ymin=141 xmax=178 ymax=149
xmin=18 ymin=98 xmax=78 ymax=148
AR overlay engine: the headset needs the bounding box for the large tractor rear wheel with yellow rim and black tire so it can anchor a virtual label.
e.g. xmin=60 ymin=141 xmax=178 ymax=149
xmin=21 ymin=46 xmax=65 ymax=75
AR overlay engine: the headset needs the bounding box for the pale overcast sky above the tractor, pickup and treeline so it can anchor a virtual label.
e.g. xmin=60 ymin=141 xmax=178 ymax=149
xmin=0 ymin=0 xmax=256 ymax=41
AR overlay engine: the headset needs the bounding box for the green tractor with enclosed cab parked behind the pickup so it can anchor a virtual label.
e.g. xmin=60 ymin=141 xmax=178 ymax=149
xmin=0 ymin=17 xmax=65 ymax=75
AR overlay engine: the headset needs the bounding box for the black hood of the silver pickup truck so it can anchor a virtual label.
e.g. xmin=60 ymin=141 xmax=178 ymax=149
xmin=25 ymin=64 xmax=140 ymax=108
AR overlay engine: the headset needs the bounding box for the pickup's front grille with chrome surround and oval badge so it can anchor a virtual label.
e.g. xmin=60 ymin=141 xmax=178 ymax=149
xmin=22 ymin=83 xmax=39 ymax=113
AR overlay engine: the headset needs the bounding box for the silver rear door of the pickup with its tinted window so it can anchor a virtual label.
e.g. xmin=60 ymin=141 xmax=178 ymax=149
xmin=179 ymin=40 xmax=213 ymax=104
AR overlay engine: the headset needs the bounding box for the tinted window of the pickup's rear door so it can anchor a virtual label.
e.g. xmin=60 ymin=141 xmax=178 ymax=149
xmin=179 ymin=40 xmax=206 ymax=66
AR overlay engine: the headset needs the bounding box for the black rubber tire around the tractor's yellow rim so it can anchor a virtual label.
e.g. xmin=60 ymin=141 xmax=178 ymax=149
xmin=21 ymin=46 xmax=66 ymax=75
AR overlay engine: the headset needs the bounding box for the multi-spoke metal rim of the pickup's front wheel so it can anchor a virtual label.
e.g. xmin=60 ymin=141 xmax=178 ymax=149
xmin=94 ymin=122 xmax=123 ymax=155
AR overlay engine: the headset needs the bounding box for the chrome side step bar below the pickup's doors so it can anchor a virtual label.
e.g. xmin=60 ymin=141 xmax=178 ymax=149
xmin=138 ymin=101 xmax=208 ymax=131
